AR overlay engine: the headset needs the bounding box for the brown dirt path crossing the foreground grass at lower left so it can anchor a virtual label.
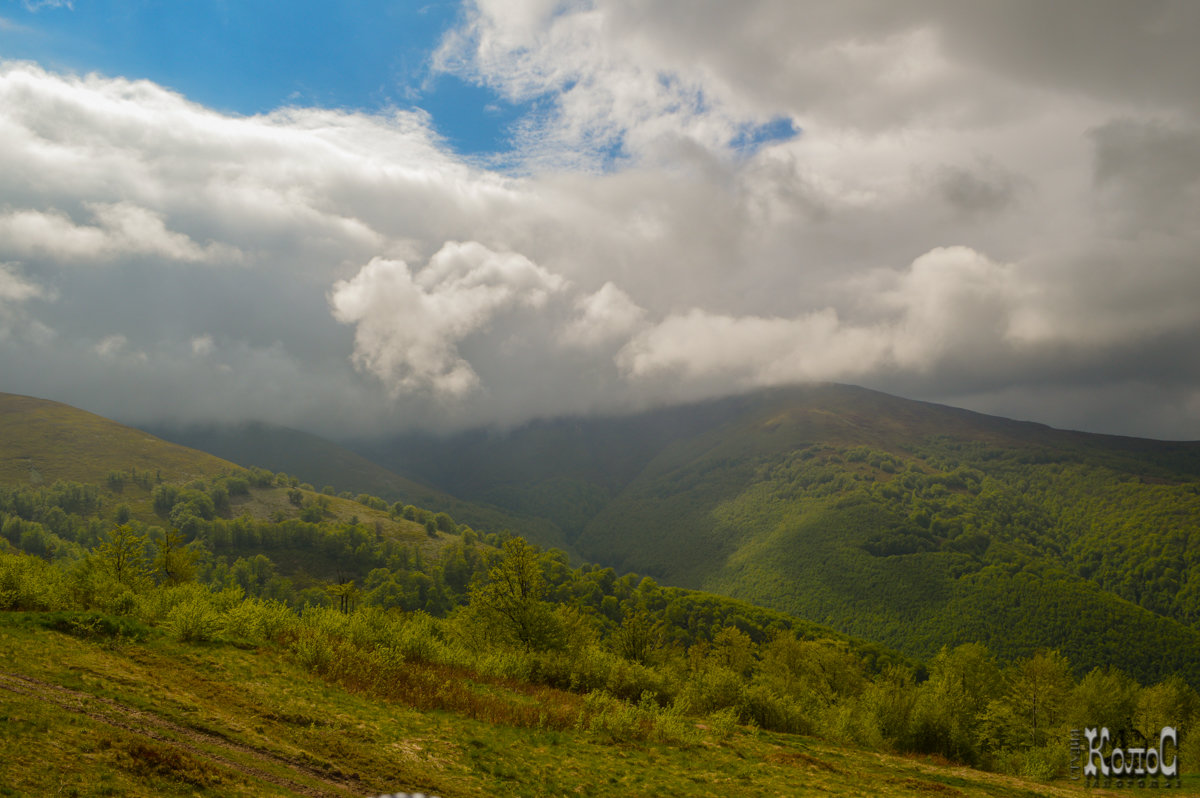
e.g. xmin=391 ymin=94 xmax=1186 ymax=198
xmin=0 ymin=671 xmax=371 ymax=798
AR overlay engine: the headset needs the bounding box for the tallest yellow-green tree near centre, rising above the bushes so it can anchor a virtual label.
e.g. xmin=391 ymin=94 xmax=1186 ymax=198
xmin=470 ymin=538 xmax=562 ymax=652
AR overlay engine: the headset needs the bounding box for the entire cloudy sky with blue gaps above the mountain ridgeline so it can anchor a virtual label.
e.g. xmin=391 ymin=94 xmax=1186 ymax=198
xmin=0 ymin=0 xmax=1200 ymax=439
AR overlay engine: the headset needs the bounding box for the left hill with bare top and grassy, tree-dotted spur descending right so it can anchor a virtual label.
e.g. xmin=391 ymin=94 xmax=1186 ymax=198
xmin=0 ymin=394 xmax=439 ymax=551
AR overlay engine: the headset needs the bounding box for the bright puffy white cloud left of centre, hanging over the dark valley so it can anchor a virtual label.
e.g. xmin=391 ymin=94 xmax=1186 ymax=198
xmin=329 ymin=241 xmax=565 ymax=397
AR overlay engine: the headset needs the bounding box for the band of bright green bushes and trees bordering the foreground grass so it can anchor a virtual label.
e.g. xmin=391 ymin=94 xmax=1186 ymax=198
xmin=0 ymin=528 xmax=1200 ymax=779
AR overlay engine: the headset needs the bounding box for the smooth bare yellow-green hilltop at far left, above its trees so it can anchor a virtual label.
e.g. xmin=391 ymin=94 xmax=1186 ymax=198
xmin=0 ymin=394 xmax=238 ymax=485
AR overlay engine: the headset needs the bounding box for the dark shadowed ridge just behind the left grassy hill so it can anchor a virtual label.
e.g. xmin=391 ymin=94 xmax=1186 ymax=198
xmin=145 ymin=421 xmax=571 ymax=551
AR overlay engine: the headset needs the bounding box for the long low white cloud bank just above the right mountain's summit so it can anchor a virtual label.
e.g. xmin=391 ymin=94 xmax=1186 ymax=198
xmin=617 ymin=247 xmax=1019 ymax=386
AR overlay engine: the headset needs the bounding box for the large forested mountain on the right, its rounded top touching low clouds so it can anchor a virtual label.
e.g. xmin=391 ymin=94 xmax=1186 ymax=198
xmin=358 ymin=385 xmax=1200 ymax=683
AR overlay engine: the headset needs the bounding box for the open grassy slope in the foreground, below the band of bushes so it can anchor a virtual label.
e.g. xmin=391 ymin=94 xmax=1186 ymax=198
xmin=0 ymin=613 xmax=1123 ymax=798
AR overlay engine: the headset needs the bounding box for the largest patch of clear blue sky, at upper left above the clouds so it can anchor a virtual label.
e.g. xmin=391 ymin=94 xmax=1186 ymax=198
xmin=0 ymin=0 xmax=528 ymax=154
